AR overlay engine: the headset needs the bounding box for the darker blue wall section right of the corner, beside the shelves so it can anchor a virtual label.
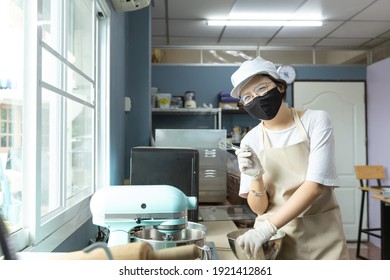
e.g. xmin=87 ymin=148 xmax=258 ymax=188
xmin=123 ymin=7 xmax=151 ymax=182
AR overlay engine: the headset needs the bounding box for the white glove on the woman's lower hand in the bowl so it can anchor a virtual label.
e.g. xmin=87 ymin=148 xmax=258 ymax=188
xmin=237 ymin=219 xmax=277 ymax=259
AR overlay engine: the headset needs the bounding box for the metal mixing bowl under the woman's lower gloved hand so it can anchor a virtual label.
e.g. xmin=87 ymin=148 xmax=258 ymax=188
xmin=227 ymin=228 xmax=285 ymax=260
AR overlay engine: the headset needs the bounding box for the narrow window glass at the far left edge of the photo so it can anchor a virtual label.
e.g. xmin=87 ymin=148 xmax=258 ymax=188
xmin=0 ymin=0 xmax=25 ymax=232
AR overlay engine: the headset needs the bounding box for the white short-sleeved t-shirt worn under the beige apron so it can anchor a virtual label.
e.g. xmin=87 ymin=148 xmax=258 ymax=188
xmin=239 ymin=109 xmax=337 ymax=197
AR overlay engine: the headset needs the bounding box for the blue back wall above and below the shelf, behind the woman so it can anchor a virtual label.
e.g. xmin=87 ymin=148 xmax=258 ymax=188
xmin=152 ymin=64 xmax=366 ymax=144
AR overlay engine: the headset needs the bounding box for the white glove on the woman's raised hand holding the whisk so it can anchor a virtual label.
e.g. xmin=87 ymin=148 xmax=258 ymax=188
xmin=235 ymin=144 xmax=264 ymax=179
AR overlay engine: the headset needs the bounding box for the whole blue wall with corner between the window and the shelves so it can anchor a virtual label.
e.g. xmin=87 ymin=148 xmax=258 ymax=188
xmin=110 ymin=7 xmax=151 ymax=185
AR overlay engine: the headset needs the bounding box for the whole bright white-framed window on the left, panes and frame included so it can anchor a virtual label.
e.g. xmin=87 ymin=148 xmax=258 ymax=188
xmin=0 ymin=0 xmax=109 ymax=250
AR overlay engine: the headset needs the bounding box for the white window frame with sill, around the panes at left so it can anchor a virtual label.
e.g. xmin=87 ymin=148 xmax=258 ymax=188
xmin=7 ymin=0 xmax=111 ymax=252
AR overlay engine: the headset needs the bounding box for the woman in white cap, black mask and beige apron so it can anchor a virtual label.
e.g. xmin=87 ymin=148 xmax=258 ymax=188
xmin=231 ymin=57 xmax=348 ymax=260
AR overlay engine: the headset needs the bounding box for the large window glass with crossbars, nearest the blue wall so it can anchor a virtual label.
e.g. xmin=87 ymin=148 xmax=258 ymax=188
xmin=40 ymin=0 xmax=96 ymax=223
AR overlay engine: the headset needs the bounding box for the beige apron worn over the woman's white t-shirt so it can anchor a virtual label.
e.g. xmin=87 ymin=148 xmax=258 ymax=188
xmin=255 ymin=109 xmax=348 ymax=260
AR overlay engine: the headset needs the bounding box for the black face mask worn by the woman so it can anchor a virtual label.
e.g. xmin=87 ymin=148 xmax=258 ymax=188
xmin=244 ymin=87 xmax=283 ymax=120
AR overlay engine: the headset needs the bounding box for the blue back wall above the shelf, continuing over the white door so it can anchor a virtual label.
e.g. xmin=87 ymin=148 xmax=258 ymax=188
xmin=152 ymin=64 xmax=366 ymax=107
